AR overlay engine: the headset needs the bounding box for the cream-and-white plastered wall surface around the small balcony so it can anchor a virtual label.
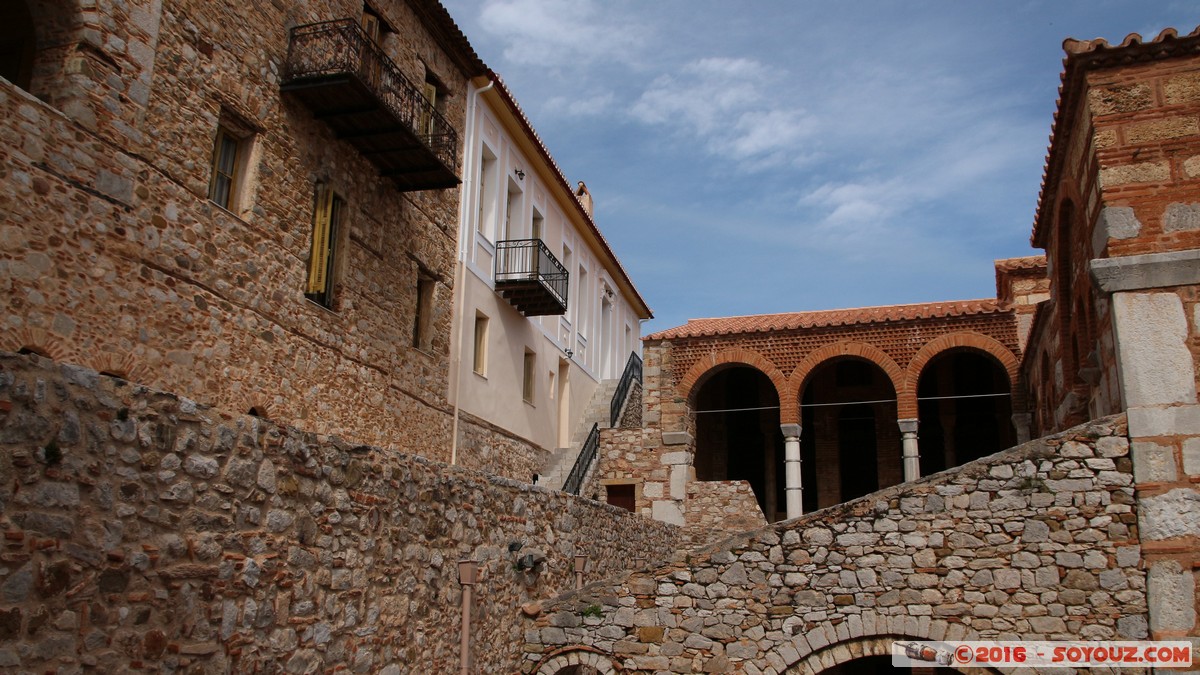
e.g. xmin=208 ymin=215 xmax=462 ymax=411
xmin=451 ymin=84 xmax=641 ymax=448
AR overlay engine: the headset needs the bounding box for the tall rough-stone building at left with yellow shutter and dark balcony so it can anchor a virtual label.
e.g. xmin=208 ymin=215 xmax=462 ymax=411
xmin=0 ymin=0 xmax=506 ymax=474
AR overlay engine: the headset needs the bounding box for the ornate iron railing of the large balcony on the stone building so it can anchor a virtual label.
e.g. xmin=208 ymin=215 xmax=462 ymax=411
xmin=283 ymin=19 xmax=458 ymax=173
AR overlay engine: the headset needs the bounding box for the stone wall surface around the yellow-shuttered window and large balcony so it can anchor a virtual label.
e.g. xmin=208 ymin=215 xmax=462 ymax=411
xmin=0 ymin=0 xmax=516 ymax=476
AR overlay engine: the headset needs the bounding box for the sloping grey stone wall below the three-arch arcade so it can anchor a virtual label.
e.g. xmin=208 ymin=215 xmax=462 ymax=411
xmin=523 ymin=417 xmax=1142 ymax=673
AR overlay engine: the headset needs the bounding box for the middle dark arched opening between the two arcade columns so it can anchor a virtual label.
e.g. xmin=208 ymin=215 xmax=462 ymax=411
xmin=800 ymin=356 xmax=904 ymax=513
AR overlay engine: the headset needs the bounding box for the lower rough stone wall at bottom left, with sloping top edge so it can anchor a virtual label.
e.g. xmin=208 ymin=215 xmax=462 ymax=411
xmin=0 ymin=354 xmax=678 ymax=675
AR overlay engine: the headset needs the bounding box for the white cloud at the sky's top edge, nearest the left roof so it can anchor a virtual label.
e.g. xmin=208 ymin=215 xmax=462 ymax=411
xmin=480 ymin=0 xmax=646 ymax=68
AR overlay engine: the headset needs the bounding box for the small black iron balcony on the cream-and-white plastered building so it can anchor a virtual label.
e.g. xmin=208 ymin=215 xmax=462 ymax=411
xmin=496 ymin=239 xmax=568 ymax=316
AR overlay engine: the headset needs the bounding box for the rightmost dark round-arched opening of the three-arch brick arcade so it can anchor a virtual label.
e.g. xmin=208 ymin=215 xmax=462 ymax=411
xmin=917 ymin=348 xmax=1016 ymax=476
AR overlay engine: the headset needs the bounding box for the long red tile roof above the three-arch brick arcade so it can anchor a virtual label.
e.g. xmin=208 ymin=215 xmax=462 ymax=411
xmin=646 ymin=298 xmax=1009 ymax=340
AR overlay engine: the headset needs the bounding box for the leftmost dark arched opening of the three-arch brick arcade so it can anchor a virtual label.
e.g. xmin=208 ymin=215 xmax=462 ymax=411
xmin=692 ymin=364 xmax=786 ymax=522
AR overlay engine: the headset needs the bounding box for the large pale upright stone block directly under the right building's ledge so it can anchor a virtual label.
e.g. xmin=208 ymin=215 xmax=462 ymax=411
xmin=1112 ymin=293 xmax=1196 ymax=403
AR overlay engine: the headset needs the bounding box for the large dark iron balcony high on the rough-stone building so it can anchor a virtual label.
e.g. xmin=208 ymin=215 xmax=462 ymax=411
xmin=280 ymin=19 xmax=458 ymax=191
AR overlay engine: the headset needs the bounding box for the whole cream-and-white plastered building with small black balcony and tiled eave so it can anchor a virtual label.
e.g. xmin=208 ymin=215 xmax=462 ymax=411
xmin=451 ymin=74 xmax=652 ymax=494
